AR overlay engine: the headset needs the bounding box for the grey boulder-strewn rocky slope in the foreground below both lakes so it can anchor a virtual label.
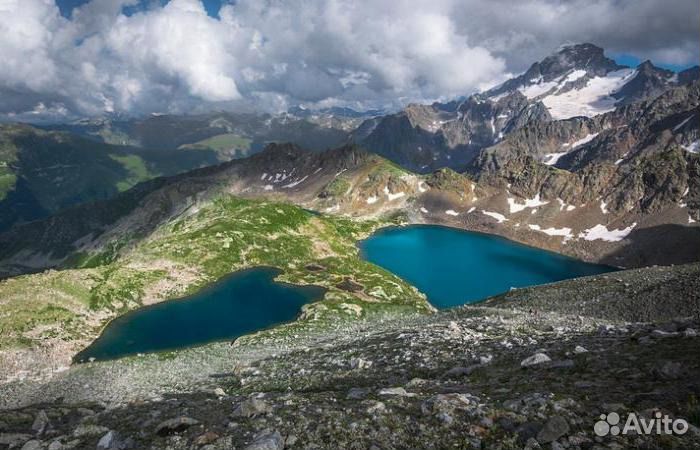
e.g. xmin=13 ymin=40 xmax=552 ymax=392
xmin=0 ymin=264 xmax=700 ymax=450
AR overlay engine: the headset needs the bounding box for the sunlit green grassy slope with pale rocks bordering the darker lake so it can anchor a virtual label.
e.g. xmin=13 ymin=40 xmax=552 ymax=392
xmin=0 ymin=196 xmax=430 ymax=349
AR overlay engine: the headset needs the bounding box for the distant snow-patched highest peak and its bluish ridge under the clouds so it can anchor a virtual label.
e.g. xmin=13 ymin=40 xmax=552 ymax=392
xmin=354 ymin=44 xmax=698 ymax=173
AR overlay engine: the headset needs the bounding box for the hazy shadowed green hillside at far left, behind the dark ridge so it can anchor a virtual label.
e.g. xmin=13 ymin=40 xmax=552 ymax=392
xmin=0 ymin=125 xmax=217 ymax=230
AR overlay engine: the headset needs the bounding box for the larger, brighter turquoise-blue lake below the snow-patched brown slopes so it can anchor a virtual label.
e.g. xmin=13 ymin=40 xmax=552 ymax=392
xmin=360 ymin=225 xmax=615 ymax=308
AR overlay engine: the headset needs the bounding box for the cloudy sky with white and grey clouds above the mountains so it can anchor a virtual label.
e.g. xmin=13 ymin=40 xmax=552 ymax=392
xmin=0 ymin=0 xmax=700 ymax=122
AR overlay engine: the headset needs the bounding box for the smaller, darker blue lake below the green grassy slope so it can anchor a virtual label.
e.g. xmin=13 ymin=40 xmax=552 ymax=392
xmin=74 ymin=267 xmax=325 ymax=361
